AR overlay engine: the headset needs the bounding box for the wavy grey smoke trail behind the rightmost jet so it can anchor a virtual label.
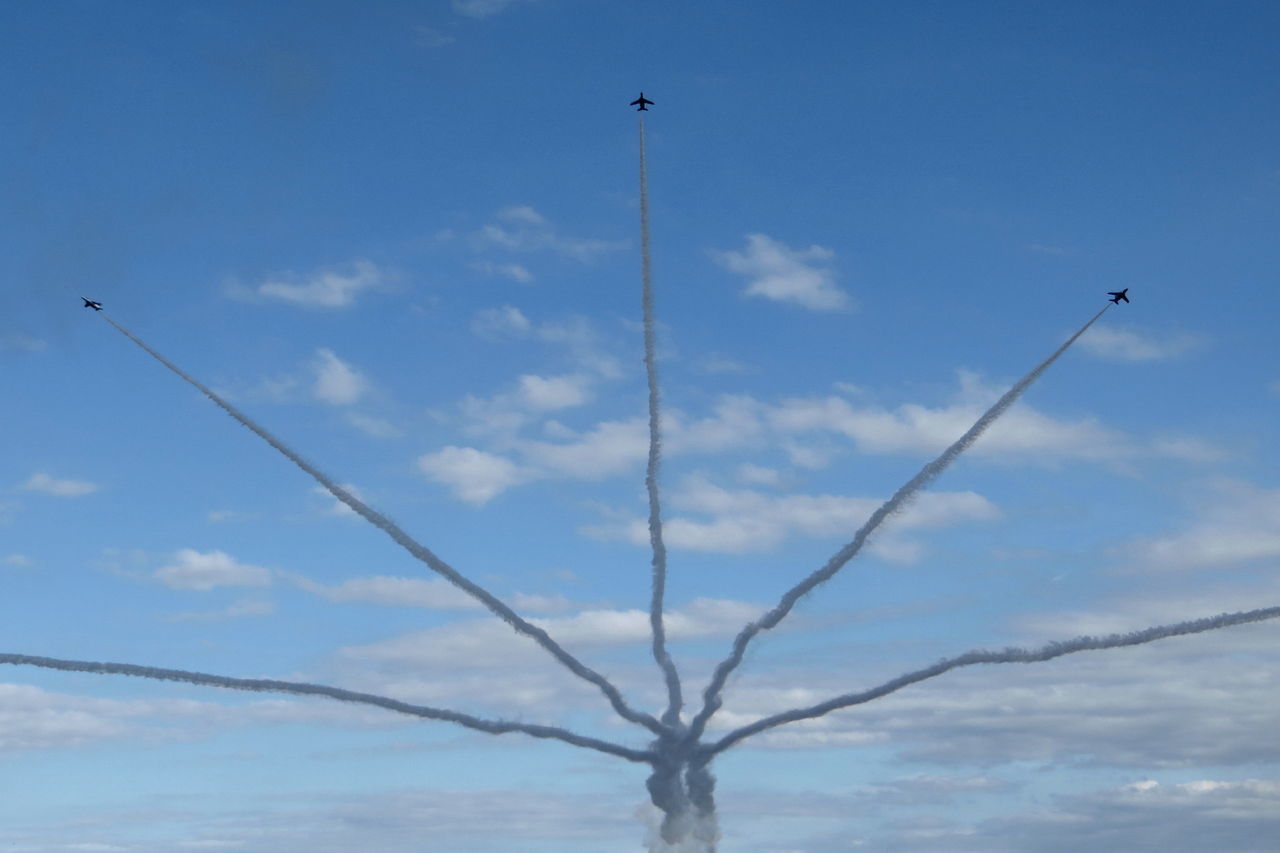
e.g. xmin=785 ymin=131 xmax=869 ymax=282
xmin=689 ymin=305 xmax=1111 ymax=742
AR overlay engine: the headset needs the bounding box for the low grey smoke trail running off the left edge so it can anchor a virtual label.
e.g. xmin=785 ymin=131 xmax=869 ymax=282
xmin=0 ymin=654 xmax=652 ymax=762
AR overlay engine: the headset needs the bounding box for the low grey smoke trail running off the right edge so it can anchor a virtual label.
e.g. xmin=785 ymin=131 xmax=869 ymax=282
xmin=703 ymin=607 xmax=1280 ymax=756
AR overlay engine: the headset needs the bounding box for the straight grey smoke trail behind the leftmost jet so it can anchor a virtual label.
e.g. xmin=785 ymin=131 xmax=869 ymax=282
xmin=99 ymin=311 xmax=666 ymax=735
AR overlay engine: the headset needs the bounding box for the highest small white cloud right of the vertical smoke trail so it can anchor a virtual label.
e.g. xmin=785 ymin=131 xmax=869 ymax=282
xmin=712 ymin=234 xmax=852 ymax=311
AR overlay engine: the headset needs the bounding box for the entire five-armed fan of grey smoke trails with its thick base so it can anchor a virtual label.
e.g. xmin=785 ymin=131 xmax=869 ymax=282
xmin=10 ymin=111 xmax=1280 ymax=853
